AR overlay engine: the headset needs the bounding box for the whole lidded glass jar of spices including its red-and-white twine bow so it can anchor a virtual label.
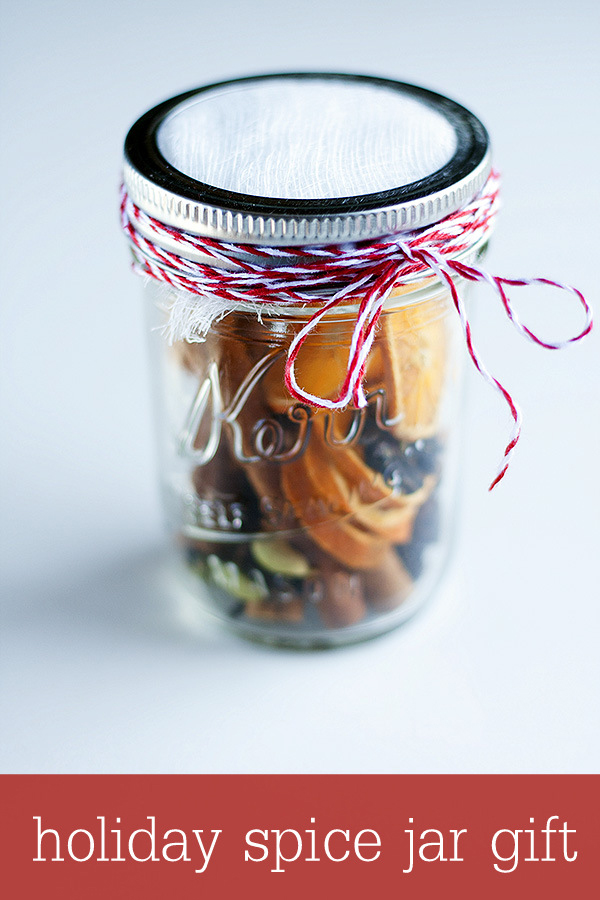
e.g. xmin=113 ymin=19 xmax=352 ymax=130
xmin=122 ymin=74 xmax=591 ymax=646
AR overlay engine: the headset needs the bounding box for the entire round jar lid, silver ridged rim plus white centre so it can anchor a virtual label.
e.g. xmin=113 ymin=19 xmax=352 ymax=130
xmin=124 ymin=73 xmax=491 ymax=246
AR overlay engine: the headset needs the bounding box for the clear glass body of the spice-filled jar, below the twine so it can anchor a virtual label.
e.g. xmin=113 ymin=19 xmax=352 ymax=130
xmin=146 ymin=282 xmax=464 ymax=647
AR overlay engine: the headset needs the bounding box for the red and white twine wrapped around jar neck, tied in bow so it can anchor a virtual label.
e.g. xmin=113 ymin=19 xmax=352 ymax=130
xmin=121 ymin=172 xmax=592 ymax=490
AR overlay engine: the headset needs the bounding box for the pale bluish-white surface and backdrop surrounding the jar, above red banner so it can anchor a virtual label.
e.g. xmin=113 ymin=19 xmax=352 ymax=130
xmin=0 ymin=0 xmax=600 ymax=772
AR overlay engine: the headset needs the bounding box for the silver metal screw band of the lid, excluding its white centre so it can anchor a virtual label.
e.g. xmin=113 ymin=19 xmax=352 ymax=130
xmin=124 ymin=73 xmax=491 ymax=246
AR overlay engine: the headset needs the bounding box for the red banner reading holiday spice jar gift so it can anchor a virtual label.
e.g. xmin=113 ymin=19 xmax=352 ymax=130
xmin=0 ymin=775 xmax=600 ymax=900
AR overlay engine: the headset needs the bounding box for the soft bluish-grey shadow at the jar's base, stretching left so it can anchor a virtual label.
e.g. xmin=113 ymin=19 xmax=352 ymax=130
xmin=2 ymin=546 xmax=460 ymax=659
